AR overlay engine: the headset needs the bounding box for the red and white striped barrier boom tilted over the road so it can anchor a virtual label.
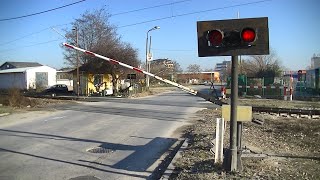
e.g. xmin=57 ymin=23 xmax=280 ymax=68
xmin=63 ymin=43 xmax=221 ymax=104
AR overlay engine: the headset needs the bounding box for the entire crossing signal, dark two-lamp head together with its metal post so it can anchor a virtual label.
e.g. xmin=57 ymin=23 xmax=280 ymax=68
xmin=197 ymin=17 xmax=269 ymax=171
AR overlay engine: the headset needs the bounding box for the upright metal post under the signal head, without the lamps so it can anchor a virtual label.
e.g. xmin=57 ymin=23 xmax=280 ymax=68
xmin=230 ymin=56 xmax=238 ymax=171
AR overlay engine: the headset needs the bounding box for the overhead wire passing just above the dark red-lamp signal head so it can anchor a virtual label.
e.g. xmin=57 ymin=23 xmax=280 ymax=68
xmin=118 ymin=0 xmax=272 ymax=28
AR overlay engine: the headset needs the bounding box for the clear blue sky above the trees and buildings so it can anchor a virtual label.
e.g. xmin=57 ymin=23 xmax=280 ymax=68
xmin=0 ymin=0 xmax=320 ymax=70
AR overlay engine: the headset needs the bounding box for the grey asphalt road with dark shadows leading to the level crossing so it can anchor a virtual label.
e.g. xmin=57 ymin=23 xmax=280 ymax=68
xmin=0 ymin=91 xmax=214 ymax=180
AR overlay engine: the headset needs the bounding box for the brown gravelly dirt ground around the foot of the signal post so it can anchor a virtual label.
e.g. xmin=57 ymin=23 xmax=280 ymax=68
xmin=170 ymin=100 xmax=320 ymax=180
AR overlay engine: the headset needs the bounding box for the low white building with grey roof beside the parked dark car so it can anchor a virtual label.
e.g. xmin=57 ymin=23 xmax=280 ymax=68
xmin=0 ymin=66 xmax=57 ymax=90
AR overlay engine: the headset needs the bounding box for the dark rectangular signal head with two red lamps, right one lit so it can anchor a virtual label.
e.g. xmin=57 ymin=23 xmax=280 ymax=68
xmin=197 ymin=17 xmax=269 ymax=57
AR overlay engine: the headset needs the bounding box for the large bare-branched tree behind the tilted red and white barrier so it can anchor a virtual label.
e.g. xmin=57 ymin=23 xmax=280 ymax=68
xmin=64 ymin=9 xmax=140 ymax=91
